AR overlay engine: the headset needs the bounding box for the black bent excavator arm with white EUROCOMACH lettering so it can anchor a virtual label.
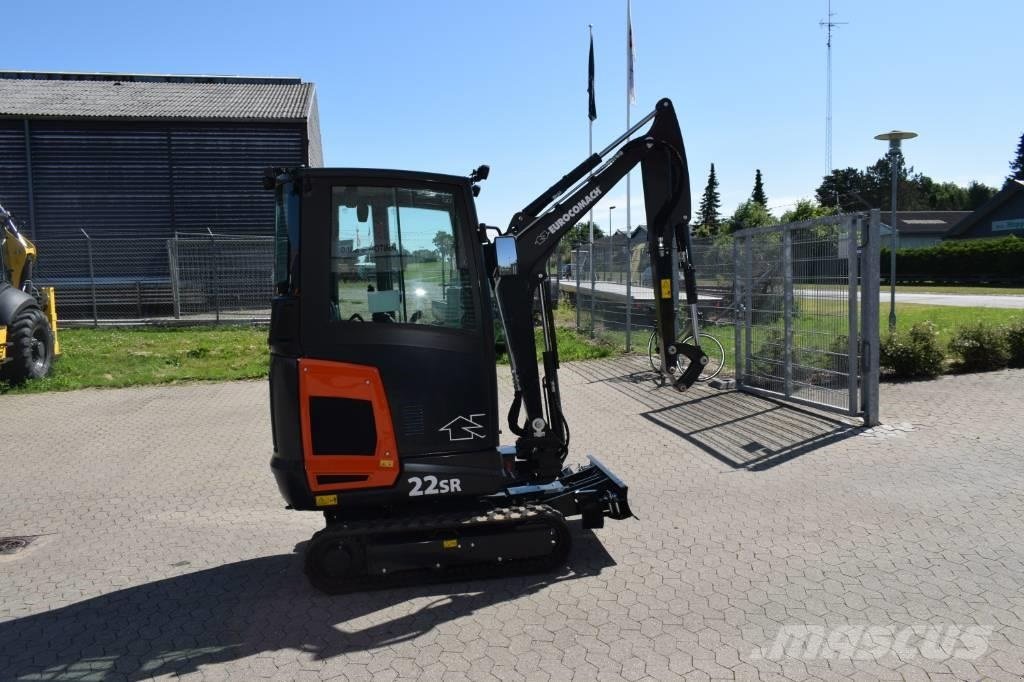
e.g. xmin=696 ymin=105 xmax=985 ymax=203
xmin=484 ymin=99 xmax=707 ymax=478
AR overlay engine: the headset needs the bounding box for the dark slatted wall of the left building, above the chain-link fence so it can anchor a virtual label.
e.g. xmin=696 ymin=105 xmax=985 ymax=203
xmin=0 ymin=119 xmax=307 ymax=240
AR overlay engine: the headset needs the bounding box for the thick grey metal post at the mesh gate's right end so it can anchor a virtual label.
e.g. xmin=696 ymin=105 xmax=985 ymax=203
xmin=860 ymin=209 xmax=882 ymax=419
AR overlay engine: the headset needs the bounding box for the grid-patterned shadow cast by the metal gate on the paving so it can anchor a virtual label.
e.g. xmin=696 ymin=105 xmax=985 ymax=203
xmin=571 ymin=356 xmax=864 ymax=471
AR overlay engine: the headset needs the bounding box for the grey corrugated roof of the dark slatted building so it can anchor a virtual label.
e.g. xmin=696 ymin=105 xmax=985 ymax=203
xmin=0 ymin=74 xmax=313 ymax=121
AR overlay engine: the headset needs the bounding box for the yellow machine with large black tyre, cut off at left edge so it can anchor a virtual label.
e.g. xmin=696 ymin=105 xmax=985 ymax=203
xmin=0 ymin=201 xmax=60 ymax=384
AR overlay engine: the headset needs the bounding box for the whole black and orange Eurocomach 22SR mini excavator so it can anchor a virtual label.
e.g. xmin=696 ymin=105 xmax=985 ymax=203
xmin=266 ymin=99 xmax=707 ymax=593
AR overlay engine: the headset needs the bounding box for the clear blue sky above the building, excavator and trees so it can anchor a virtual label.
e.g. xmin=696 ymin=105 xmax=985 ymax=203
xmin=0 ymin=0 xmax=1024 ymax=228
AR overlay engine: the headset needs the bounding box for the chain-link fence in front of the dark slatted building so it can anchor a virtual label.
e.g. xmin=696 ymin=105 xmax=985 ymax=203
xmin=33 ymin=231 xmax=273 ymax=325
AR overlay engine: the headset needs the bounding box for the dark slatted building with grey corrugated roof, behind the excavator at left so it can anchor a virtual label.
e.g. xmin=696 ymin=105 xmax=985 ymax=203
xmin=0 ymin=72 xmax=323 ymax=316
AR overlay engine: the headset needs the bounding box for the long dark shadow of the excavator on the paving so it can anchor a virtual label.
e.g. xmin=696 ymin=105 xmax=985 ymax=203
xmin=0 ymin=524 xmax=614 ymax=680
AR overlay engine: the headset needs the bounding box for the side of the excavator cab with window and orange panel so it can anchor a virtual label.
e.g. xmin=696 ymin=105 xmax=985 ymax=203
xmin=299 ymin=169 xmax=499 ymax=491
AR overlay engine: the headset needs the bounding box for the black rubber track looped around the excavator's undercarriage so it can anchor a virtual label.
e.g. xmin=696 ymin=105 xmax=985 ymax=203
xmin=306 ymin=504 xmax=571 ymax=594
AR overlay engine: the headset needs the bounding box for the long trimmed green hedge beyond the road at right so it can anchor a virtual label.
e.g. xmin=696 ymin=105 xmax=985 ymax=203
xmin=882 ymin=236 xmax=1024 ymax=283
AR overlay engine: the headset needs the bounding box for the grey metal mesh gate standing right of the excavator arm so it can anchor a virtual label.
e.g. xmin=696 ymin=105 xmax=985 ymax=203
xmin=733 ymin=210 xmax=879 ymax=424
